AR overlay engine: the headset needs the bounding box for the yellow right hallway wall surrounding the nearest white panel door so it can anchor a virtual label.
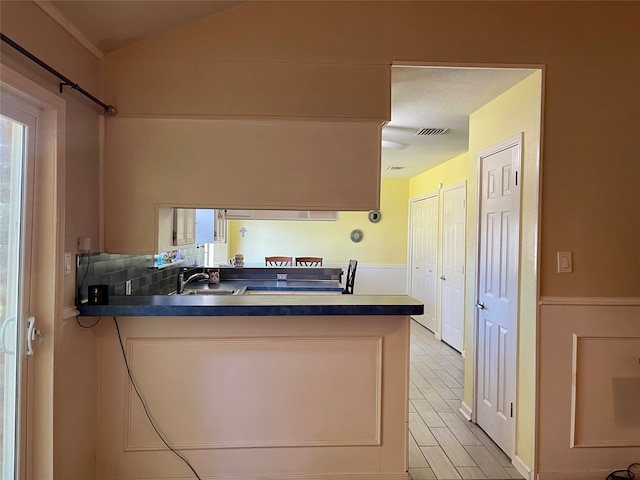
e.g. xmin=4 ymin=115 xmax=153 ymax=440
xmin=398 ymin=65 xmax=544 ymax=477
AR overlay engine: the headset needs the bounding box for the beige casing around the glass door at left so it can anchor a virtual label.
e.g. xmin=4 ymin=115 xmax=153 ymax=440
xmin=0 ymin=64 xmax=66 ymax=479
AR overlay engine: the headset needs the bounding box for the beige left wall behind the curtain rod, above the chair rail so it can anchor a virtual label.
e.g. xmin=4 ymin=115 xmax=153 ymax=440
xmin=0 ymin=1 xmax=102 ymax=305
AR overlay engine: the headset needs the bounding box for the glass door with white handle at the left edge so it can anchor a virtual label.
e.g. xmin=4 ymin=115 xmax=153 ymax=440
xmin=0 ymin=87 xmax=38 ymax=479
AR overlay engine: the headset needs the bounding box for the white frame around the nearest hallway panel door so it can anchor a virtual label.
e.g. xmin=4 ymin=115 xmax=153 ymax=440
xmin=471 ymin=132 xmax=524 ymax=460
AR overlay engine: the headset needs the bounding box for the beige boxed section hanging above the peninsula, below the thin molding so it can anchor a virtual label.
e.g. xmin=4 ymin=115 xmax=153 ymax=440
xmin=102 ymin=117 xmax=381 ymax=254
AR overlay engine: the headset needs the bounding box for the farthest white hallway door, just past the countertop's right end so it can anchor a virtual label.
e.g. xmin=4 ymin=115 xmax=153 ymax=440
xmin=410 ymin=194 xmax=438 ymax=332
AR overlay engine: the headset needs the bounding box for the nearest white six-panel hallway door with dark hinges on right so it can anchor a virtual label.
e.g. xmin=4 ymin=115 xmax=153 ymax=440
xmin=476 ymin=136 xmax=521 ymax=456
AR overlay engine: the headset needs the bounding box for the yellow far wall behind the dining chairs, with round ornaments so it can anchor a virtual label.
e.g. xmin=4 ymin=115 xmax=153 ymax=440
xmin=228 ymin=179 xmax=409 ymax=265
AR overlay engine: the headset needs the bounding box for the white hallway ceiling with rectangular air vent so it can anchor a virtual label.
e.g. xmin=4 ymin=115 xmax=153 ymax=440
xmin=382 ymin=66 xmax=534 ymax=178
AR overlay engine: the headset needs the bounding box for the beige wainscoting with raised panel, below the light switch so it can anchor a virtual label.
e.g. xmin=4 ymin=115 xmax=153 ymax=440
xmin=537 ymin=298 xmax=640 ymax=480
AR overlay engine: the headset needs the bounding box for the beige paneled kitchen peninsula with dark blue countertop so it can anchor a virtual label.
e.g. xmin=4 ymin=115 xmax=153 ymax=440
xmin=78 ymin=295 xmax=423 ymax=480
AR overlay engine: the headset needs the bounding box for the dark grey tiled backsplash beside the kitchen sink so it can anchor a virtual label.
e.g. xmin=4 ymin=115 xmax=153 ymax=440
xmin=76 ymin=245 xmax=204 ymax=304
